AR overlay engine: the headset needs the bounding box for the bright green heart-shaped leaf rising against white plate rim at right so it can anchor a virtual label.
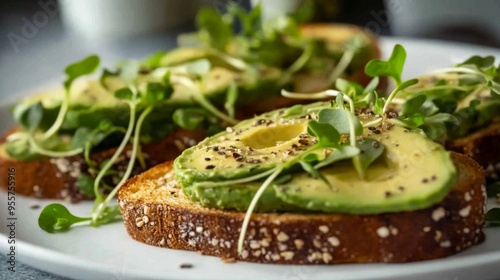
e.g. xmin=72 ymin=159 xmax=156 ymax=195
xmin=365 ymin=44 xmax=406 ymax=85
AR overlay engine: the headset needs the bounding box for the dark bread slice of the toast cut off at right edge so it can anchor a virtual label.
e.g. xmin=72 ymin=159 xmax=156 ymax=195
xmin=446 ymin=122 xmax=500 ymax=180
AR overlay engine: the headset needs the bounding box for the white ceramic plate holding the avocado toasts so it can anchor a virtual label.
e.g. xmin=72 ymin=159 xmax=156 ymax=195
xmin=0 ymin=38 xmax=500 ymax=280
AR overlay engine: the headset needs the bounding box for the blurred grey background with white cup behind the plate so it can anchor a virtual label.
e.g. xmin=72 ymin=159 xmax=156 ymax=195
xmin=0 ymin=0 xmax=500 ymax=96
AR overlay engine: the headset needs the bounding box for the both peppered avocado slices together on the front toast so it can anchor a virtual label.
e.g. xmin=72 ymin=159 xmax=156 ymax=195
xmin=174 ymin=102 xmax=456 ymax=214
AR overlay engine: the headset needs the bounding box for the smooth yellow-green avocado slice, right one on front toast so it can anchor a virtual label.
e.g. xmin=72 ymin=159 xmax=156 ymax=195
xmin=274 ymin=126 xmax=456 ymax=214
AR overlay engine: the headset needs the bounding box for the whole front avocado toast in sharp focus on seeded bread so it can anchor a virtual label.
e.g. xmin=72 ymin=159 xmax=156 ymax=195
xmin=118 ymin=100 xmax=485 ymax=264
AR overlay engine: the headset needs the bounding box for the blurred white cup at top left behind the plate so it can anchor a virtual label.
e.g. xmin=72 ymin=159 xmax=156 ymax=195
xmin=59 ymin=0 xmax=206 ymax=40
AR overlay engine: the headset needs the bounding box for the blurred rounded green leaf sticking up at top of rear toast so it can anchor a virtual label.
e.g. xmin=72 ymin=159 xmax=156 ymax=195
xmin=196 ymin=7 xmax=233 ymax=51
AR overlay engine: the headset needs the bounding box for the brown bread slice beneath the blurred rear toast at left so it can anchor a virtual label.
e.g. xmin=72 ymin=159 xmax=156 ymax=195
xmin=0 ymin=130 xmax=206 ymax=202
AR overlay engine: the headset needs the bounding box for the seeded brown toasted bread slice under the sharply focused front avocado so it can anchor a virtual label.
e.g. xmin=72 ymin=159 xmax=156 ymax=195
xmin=118 ymin=153 xmax=485 ymax=264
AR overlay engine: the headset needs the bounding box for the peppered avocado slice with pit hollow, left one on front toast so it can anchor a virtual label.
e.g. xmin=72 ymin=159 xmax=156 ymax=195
xmin=174 ymin=102 xmax=328 ymax=188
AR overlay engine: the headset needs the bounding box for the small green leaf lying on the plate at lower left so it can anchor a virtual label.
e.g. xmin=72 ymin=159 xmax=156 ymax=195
xmin=38 ymin=203 xmax=92 ymax=233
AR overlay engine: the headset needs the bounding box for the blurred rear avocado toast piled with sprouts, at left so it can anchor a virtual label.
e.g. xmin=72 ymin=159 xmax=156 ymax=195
xmin=0 ymin=2 xmax=379 ymax=210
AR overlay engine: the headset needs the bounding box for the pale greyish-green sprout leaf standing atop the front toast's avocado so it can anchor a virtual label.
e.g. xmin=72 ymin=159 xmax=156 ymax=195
xmin=318 ymin=109 xmax=363 ymax=135
